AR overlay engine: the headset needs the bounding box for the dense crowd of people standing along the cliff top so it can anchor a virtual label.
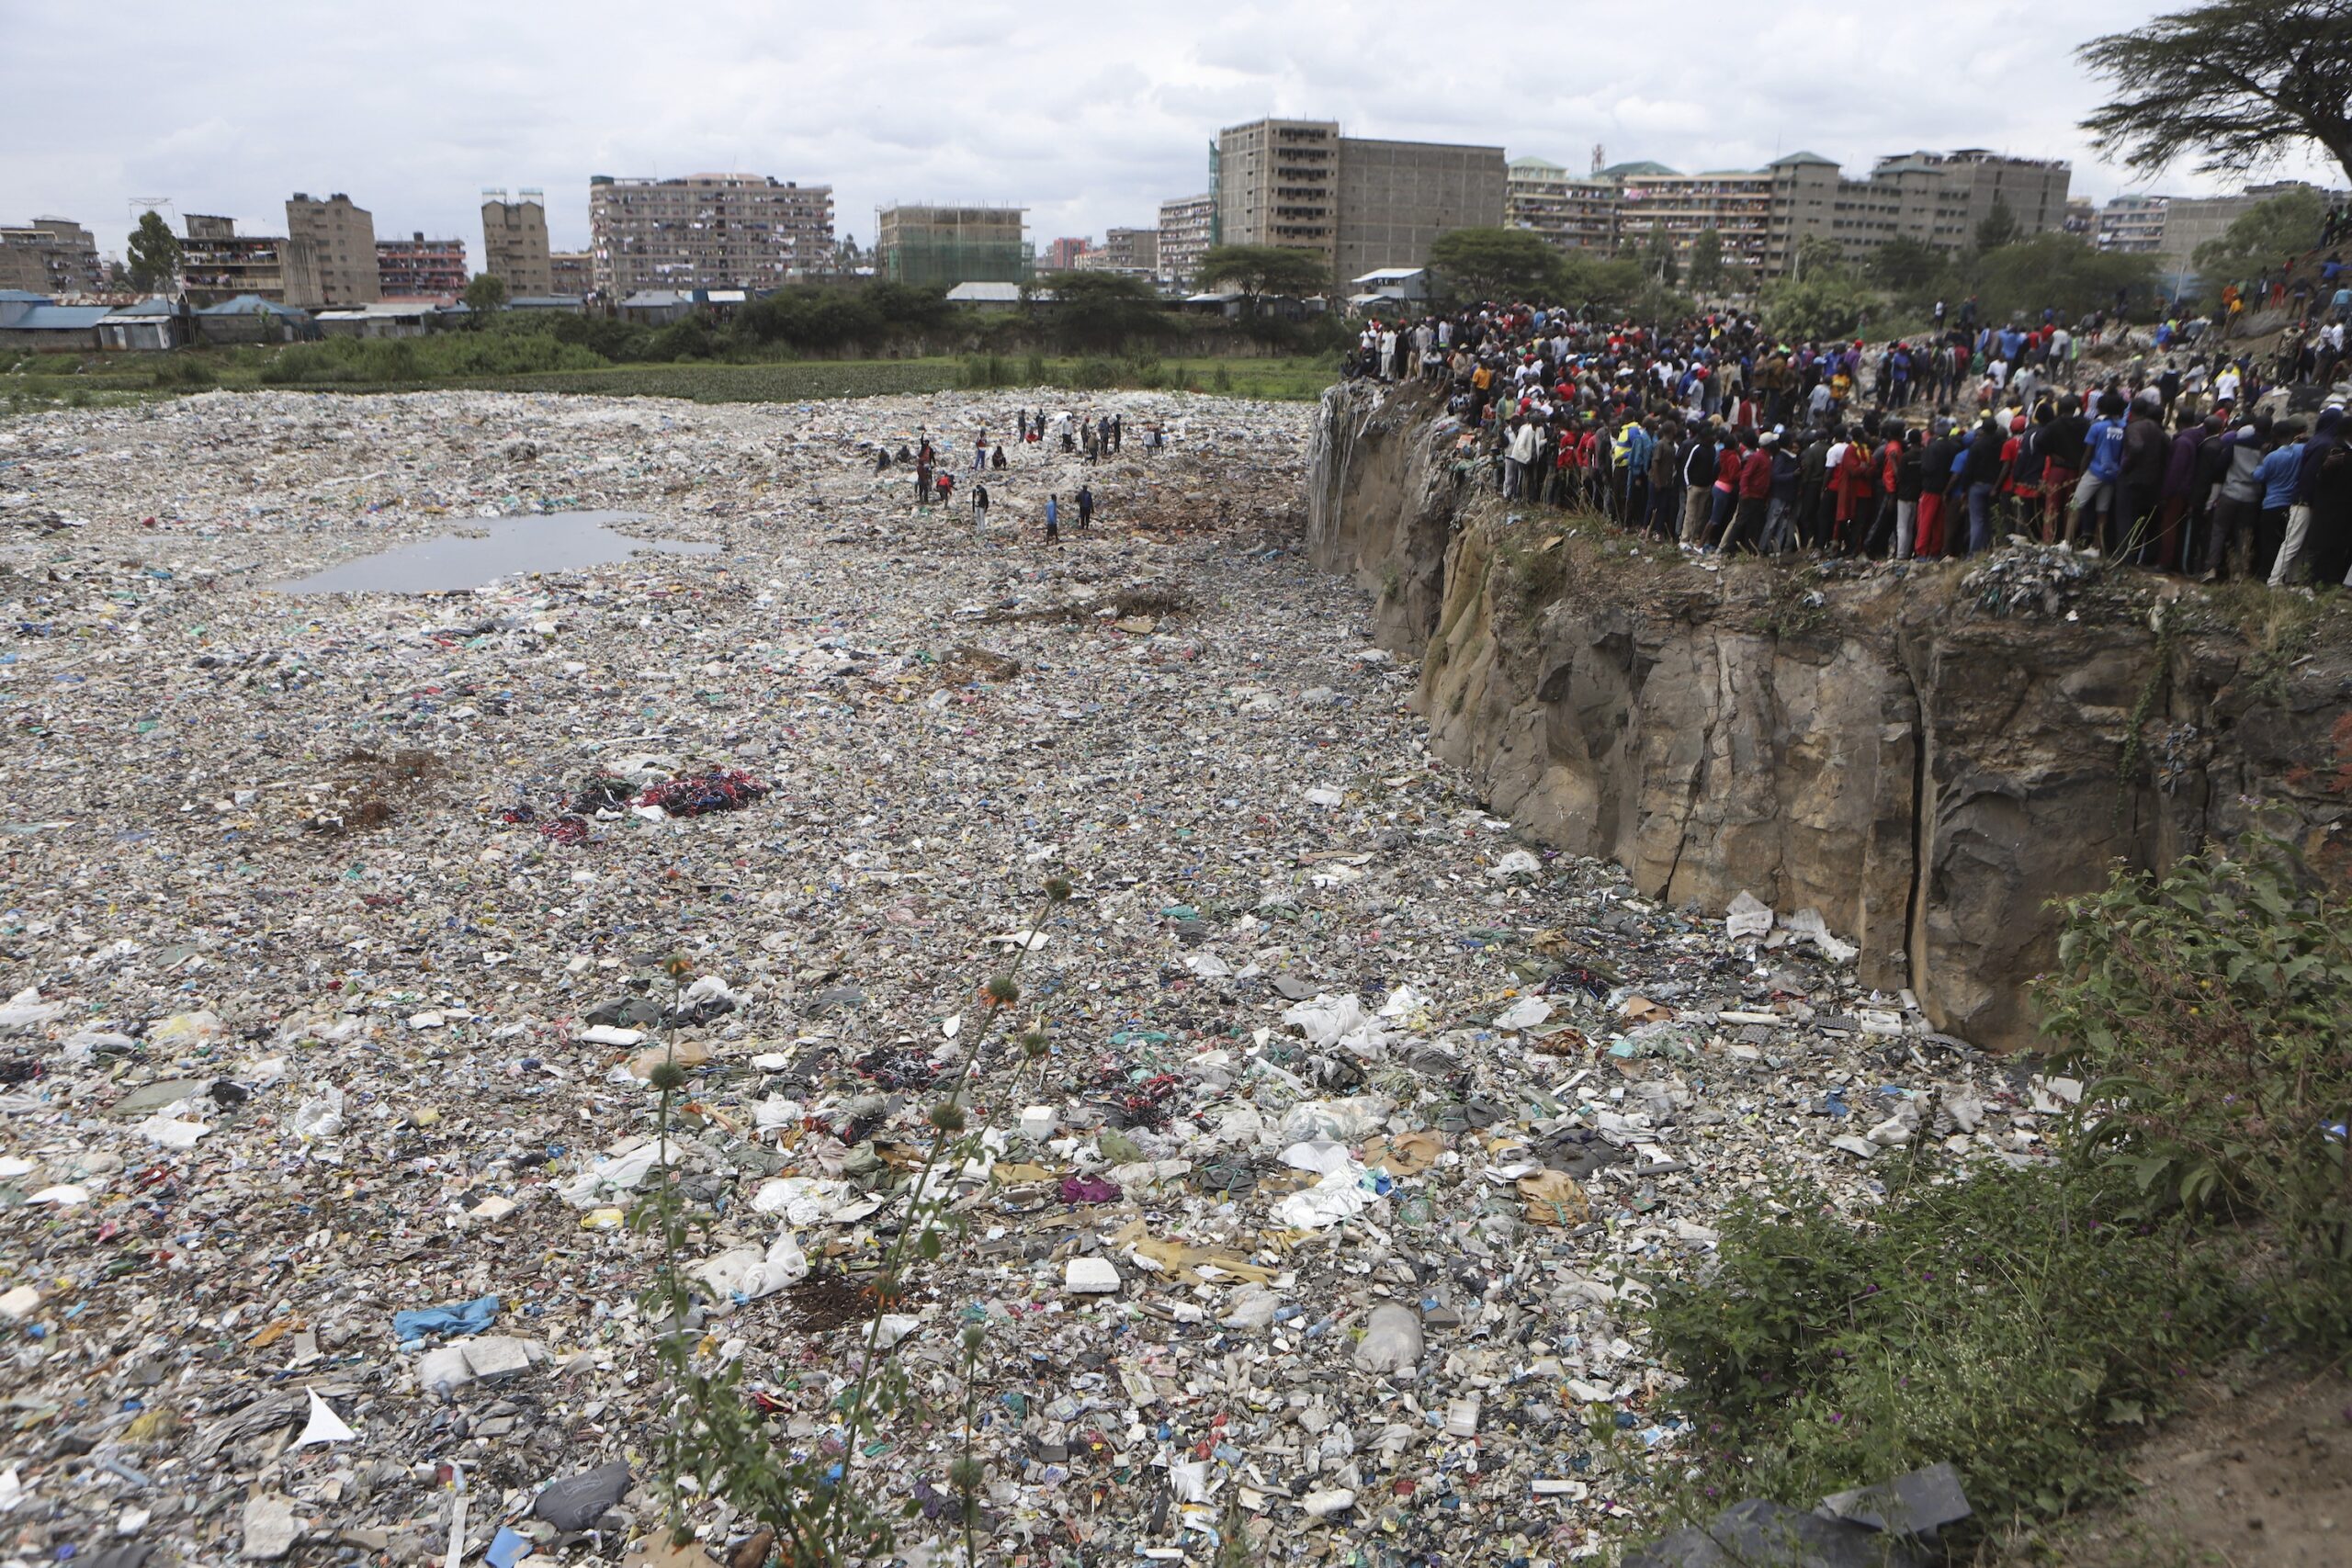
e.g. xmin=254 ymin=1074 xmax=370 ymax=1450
xmin=1350 ymin=301 xmax=2352 ymax=585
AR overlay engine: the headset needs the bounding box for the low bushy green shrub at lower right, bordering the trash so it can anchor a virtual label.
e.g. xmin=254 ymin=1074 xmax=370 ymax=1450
xmin=1651 ymin=1166 xmax=2237 ymax=1518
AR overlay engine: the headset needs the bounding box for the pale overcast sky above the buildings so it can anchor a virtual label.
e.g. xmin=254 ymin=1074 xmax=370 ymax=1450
xmin=0 ymin=0 xmax=2324 ymax=265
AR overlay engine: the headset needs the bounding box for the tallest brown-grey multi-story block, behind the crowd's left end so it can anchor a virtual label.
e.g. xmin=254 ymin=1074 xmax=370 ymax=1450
xmin=1211 ymin=120 xmax=1505 ymax=277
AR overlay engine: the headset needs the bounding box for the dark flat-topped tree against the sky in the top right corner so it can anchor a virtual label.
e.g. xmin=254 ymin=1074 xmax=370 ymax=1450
xmin=2076 ymin=0 xmax=2352 ymax=189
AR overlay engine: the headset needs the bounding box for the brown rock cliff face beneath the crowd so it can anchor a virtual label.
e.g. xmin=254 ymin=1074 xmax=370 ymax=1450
xmin=1307 ymin=386 xmax=2352 ymax=1048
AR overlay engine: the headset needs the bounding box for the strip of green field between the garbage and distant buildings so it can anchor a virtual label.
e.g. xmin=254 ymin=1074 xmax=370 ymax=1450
xmin=0 ymin=348 xmax=1339 ymax=409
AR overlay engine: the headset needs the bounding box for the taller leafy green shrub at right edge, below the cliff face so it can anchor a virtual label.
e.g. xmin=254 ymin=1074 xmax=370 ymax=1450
xmin=2037 ymin=835 xmax=2352 ymax=1337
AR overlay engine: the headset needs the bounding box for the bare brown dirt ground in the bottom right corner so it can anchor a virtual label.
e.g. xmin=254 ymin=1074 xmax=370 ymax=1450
xmin=2023 ymin=1363 xmax=2352 ymax=1568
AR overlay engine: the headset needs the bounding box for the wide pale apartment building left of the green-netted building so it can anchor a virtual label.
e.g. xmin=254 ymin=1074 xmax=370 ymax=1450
xmin=588 ymin=174 xmax=832 ymax=299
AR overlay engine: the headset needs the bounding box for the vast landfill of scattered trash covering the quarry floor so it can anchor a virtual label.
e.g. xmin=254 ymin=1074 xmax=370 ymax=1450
xmin=0 ymin=392 xmax=2079 ymax=1568
